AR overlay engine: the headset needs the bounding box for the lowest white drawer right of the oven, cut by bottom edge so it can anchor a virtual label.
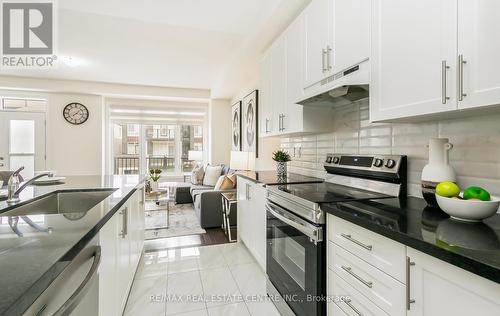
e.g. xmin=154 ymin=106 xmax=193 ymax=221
xmin=328 ymin=270 xmax=388 ymax=316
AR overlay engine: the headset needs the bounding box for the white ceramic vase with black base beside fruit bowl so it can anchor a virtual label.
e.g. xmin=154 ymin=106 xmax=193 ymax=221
xmin=422 ymin=138 xmax=457 ymax=206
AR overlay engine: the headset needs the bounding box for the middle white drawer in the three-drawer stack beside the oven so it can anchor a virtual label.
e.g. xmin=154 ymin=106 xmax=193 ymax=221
xmin=328 ymin=241 xmax=406 ymax=316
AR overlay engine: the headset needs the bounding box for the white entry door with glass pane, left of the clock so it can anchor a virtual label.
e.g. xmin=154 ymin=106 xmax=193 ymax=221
xmin=0 ymin=111 xmax=45 ymax=179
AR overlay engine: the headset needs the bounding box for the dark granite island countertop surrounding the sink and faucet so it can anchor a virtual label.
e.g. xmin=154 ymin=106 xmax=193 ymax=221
xmin=0 ymin=175 xmax=143 ymax=315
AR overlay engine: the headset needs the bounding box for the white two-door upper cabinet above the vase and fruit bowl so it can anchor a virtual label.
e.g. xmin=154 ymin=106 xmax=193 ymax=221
xmin=370 ymin=0 xmax=500 ymax=121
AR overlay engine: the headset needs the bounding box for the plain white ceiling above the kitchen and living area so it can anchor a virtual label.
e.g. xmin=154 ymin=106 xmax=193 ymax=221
xmin=0 ymin=0 xmax=310 ymax=97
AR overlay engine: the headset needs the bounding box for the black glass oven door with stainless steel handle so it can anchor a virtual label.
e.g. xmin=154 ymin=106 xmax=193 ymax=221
xmin=266 ymin=201 xmax=326 ymax=316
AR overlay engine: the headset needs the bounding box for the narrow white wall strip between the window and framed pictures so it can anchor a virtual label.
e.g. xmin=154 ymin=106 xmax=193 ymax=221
xmin=208 ymin=99 xmax=231 ymax=165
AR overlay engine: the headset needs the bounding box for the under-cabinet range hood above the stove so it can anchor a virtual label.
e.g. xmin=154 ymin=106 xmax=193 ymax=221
xmin=297 ymin=59 xmax=369 ymax=107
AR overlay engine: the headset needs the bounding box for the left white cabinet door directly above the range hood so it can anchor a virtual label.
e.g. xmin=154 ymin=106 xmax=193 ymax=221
xmin=304 ymin=0 xmax=333 ymax=87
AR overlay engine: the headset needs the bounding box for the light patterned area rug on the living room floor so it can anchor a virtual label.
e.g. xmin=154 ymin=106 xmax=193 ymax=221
xmin=145 ymin=204 xmax=206 ymax=240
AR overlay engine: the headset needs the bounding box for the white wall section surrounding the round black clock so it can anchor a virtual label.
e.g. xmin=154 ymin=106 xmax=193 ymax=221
xmin=47 ymin=93 xmax=104 ymax=175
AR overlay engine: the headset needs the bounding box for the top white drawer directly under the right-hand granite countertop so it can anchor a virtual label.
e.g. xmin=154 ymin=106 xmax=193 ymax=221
xmin=327 ymin=215 xmax=406 ymax=283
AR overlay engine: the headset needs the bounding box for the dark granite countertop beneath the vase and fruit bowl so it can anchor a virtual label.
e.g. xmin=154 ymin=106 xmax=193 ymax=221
xmin=322 ymin=197 xmax=500 ymax=283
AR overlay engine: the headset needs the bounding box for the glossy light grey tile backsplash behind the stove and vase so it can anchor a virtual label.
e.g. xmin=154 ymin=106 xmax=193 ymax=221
xmin=281 ymin=100 xmax=500 ymax=196
